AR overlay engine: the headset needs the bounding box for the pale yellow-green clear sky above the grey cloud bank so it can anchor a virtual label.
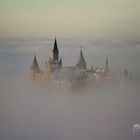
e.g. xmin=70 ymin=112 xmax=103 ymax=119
xmin=0 ymin=0 xmax=140 ymax=39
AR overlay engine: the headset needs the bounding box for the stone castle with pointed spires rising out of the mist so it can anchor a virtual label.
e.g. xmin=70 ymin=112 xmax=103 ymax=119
xmin=30 ymin=38 xmax=113 ymax=86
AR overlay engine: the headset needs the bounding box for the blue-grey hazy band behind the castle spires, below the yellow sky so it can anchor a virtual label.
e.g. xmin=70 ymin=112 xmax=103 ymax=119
xmin=0 ymin=37 xmax=140 ymax=80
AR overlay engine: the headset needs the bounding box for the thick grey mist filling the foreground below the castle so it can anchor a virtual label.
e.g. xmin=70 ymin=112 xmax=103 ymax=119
xmin=0 ymin=75 xmax=140 ymax=140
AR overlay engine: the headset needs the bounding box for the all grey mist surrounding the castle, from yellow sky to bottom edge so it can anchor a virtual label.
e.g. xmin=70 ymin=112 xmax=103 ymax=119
xmin=0 ymin=36 xmax=140 ymax=140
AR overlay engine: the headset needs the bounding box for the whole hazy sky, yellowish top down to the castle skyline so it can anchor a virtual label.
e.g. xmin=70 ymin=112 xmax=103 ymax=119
xmin=0 ymin=0 xmax=140 ymax=79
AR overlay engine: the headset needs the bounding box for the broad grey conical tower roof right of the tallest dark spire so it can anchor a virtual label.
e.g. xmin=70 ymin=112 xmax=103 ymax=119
xmin=76 ymin=47 xmax=87 ymax=69
